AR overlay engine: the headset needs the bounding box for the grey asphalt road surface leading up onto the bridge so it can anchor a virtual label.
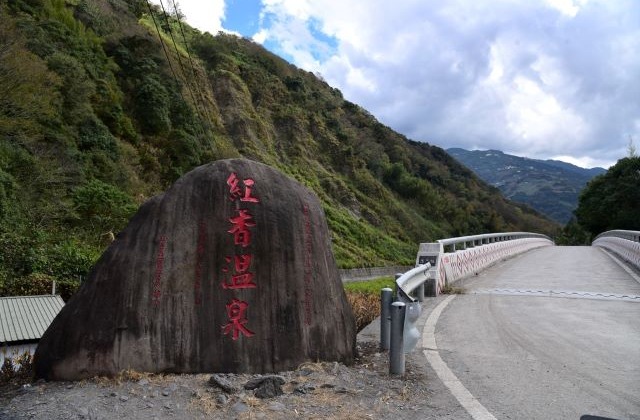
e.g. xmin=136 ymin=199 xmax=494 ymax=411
xmin=435 ymin=247 xmax=640 ymax=420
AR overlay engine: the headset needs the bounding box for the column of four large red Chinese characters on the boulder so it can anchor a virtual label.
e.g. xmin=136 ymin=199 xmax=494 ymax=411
xmin=220 ymin=172 xmax=260 ymax=341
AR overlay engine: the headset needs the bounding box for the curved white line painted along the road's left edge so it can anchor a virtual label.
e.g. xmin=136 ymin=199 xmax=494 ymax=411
xmin=422 ymin=295 xmax=496 ymax=420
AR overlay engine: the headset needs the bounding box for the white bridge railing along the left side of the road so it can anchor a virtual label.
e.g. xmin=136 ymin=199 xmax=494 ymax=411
xmin=416 ymin=232 xmax=554 ymax=295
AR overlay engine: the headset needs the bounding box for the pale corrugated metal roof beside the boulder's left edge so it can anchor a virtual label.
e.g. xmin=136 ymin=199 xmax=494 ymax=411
xmin=0 ymin=295 xmax=64 ymax=343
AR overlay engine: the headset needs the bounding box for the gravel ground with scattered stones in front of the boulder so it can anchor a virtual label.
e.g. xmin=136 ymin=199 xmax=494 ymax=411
xmin=0 ymin=298 xmax=468 ymax=420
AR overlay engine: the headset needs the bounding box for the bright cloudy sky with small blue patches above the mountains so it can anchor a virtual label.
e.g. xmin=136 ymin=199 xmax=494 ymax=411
xmin=154 ymin=0 xmax=640 ymax=168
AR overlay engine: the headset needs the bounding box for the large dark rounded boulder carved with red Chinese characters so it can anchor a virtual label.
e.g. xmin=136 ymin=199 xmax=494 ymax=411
xmin=35 ymin=159 xmax=356 ymax=380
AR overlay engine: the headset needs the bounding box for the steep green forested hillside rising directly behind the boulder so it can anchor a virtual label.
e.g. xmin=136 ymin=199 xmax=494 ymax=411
xmin=0 ymin=0 xmax=557 ymax=294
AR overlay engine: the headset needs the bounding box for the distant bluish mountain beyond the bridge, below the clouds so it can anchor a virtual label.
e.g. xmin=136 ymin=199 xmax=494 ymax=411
xmin=447 ymin=148 xmax=606 ymax=223
